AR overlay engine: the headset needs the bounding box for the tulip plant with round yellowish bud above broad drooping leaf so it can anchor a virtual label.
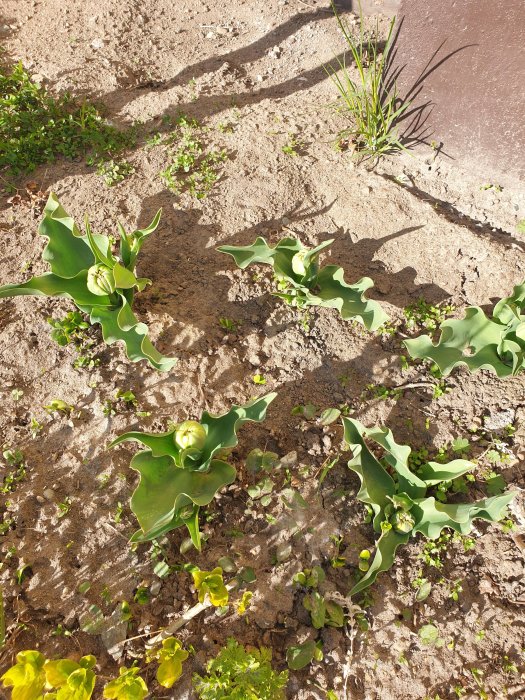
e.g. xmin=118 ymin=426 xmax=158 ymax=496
xmin=110 ymin=393 xmax=277 ymax=549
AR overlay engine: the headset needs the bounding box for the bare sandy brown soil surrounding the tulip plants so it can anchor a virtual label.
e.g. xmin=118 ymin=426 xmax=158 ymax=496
xmin=0 ymin=0 xmax=525 ymax=700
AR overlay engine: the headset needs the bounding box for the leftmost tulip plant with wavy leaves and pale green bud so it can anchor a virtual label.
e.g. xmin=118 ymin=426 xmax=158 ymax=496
xmin=0 ymin=193 xmax=176 ymax=372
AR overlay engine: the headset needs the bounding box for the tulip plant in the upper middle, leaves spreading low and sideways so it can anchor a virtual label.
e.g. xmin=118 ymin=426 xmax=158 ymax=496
xmin=217 ymin=238 xmax=388 ymax=331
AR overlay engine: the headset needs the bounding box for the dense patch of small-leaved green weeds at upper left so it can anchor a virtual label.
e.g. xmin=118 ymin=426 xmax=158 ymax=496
xmin=0 ymin=63 xmax=134 ymax=177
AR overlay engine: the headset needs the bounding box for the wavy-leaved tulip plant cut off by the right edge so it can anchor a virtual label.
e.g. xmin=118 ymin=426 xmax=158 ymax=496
xmin=404 ymin=282 xmax=525 ymax=377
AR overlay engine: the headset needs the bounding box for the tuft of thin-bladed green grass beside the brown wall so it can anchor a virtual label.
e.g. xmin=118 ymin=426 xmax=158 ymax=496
xmin=325 ymin=1 xmax=410 ymax=158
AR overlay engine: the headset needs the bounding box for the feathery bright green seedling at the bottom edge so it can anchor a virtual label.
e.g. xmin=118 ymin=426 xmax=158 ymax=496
xmin=193 ymin=639 xmax=288 ymax=700
